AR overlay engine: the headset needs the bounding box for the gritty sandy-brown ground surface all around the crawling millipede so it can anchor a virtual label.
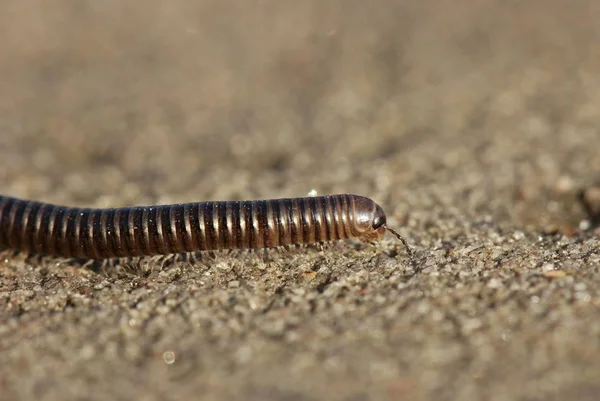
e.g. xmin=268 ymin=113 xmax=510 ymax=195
xmin=0 ymin=0 xmax=600 ymax=401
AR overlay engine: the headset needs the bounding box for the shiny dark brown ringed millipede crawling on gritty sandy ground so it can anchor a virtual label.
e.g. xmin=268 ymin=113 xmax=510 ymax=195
xmin=0 ymin=194 xmax=412 ymax=260
